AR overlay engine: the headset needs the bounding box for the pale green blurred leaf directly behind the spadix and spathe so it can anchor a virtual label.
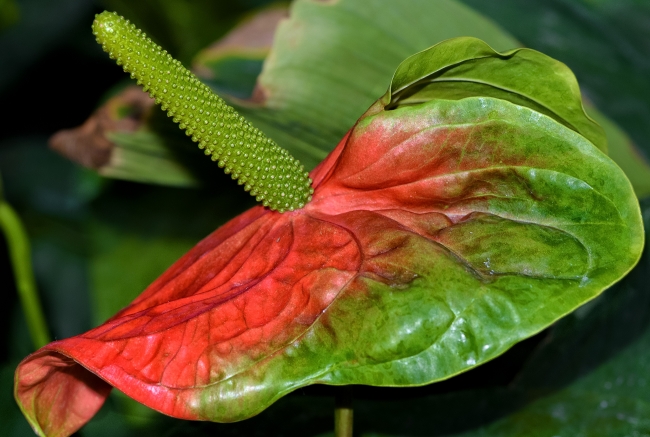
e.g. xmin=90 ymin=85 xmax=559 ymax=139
xmin=220 ymin=0 xmax=519 ymax=168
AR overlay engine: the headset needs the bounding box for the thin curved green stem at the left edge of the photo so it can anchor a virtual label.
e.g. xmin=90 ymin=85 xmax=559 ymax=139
xmin=0 ymin=198 xmax=50 ymax=349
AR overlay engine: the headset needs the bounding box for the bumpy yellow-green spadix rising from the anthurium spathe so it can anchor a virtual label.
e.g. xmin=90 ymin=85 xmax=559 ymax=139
xmin=93 ymin=12 xmax=313 ymax=212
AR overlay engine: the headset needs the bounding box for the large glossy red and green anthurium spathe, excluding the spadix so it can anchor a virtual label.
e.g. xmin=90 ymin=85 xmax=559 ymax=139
xmin=15 ymin=10 xmax=643 ymax=436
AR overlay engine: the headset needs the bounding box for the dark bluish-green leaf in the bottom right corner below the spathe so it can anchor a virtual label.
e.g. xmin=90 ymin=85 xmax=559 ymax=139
xmin=450 ymin=200 xmax=650 ymax=437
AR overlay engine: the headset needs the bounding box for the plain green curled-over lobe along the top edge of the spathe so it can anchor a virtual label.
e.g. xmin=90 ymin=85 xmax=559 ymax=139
xmin=385 ymin=37 xmax=607 ymax=152
